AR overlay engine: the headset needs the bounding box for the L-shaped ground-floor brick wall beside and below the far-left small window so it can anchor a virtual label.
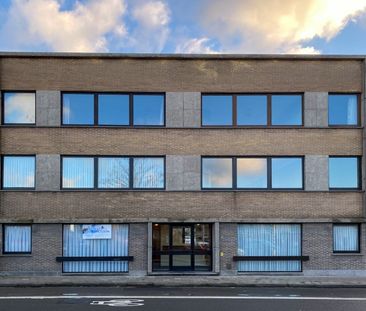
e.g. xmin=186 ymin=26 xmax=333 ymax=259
xmin=0 ymin=224 xmax=62 ymax=275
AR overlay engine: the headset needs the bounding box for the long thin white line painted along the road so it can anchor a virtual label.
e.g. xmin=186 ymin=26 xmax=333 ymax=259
xmin=0 ymin=295 xmax=366 ymax=301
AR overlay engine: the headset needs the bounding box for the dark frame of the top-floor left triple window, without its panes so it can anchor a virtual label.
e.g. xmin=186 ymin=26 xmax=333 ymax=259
xmin=61 ymin=91 xmax=166 ymax=128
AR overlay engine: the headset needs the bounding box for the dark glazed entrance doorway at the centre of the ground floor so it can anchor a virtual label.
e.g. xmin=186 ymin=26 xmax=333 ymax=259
xmin=152 ymin=224 xmax=212 ymax=271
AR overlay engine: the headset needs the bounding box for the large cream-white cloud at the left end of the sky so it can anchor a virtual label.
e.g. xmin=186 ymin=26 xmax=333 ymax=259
xmin=0 ymin=0 xmax=127 ymax=52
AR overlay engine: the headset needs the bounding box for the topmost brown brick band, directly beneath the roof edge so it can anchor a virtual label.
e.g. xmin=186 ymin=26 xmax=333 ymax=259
xmin=0 ymin=57 xmax=362 ymax=92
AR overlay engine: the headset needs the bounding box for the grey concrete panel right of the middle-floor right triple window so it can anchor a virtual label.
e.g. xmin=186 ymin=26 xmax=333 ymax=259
xmin=304 ymin=155 xmax=329 ymax=191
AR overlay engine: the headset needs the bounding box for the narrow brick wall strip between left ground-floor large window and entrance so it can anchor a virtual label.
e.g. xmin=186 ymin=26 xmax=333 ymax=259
xmin=128 ymin=223 xmax=148 ymax=275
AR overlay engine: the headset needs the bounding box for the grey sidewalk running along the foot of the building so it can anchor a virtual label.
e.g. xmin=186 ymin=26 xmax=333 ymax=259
xmin=0 ymin=275 xmax=366 ymax=287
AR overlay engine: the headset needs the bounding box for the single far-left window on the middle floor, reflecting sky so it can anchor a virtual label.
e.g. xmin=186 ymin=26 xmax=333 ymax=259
xmin=2 ymin=156 xmax=36 ymax=189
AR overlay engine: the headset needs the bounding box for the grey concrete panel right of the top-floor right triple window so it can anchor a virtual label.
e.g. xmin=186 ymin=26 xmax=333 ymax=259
xmin=304 ymin=92 xmax=328 ymax=127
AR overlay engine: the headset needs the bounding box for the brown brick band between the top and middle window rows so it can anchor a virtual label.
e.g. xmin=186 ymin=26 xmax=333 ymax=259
xmin=0 ymin=127 xmax=362 ymax=155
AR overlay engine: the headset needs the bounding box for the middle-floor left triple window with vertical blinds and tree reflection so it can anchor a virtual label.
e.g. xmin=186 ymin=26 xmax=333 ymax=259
xmin=62 ymin=156 xmax=165 ymax=189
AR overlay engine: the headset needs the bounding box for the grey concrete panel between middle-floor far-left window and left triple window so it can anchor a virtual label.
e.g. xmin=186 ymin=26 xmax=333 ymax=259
xmin=36 ymin=154 xmax=60 ymax=191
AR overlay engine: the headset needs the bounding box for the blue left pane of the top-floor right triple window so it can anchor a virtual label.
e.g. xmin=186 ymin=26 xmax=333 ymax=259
xmin=202 ymin=95 xmax=233 ymax=125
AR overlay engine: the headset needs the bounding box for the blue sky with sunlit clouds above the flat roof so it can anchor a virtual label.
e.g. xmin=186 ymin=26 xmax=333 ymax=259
xmin=0 ymin=0 xmax=366 ymax=54
